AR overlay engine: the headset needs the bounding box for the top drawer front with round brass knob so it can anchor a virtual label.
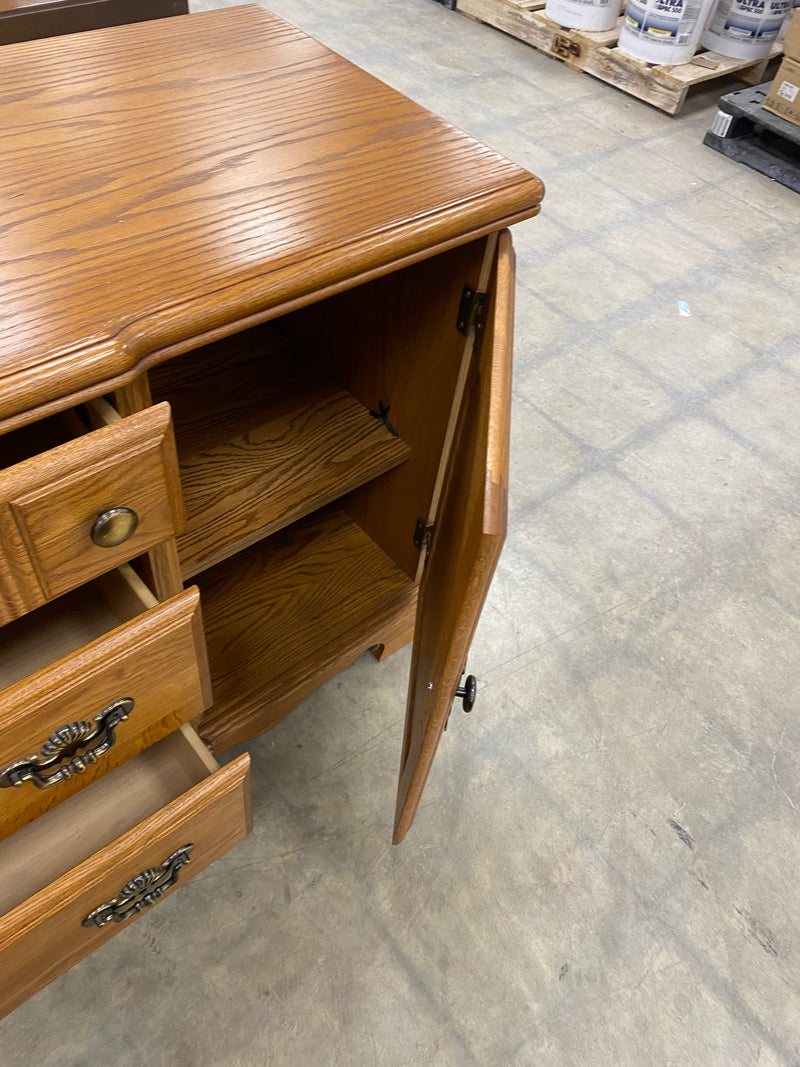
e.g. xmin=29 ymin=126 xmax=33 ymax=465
xmin=0 ymin=404 xmax=183 ymax=622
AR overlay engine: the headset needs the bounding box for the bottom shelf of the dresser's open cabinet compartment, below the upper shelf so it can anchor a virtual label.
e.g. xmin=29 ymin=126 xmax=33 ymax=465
xmin=197 ymin=507 xmax=416 ymax=750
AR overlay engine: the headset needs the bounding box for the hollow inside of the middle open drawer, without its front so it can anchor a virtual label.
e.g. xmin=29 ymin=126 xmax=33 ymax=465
xmin=0 ymin=564 xmax=156 ymax=691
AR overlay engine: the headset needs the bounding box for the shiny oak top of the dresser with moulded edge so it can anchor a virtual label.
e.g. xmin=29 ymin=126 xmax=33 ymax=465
xmin=0 ymin=6 xmax=543 ymax=428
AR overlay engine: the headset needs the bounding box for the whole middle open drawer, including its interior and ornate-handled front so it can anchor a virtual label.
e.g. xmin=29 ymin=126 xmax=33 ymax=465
xmin=0 ymin=566 xmax=211 ymax=840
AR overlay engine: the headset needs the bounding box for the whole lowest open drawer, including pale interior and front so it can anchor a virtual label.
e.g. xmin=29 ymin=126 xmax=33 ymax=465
xmin=0 ymin=727 xmax=252 ymax=1015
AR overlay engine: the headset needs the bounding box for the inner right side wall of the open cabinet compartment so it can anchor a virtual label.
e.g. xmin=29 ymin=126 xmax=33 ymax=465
xmin=285 ymin=237 xmax=495 ymax=577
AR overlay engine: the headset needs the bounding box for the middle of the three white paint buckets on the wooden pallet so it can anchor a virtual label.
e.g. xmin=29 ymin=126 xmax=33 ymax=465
xmin=618 ymin=0 xmax=714 ymax=63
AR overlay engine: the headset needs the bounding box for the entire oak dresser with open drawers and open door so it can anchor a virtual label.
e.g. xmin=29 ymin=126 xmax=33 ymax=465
xmin=0 ymin=7 xmax=543 ymax=1010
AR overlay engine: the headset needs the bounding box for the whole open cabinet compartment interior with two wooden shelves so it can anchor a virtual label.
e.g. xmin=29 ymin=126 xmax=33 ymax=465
xmin=148 ymin=239 xmax=486 ymax=750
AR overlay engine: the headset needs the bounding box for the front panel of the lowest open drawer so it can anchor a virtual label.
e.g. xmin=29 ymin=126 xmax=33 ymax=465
xmin=0 ymin=755 xmax=251 ymax=1016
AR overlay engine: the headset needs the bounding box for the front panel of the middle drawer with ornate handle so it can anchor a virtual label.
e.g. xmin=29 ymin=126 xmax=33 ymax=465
xmin=0 ymin=588 xmax=210 ymax=840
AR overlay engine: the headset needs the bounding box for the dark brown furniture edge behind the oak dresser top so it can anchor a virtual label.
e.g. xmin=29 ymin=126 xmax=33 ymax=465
xmin=0 ymin=0 xmax=189 ymax=45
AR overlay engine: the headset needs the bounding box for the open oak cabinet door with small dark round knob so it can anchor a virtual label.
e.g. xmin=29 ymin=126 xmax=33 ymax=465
xmin=395 ymin=230 xmax=514 ymax=844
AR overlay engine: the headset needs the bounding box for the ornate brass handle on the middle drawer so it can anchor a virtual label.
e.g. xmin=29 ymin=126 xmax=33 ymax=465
xmin=0 ymin=697 xmax=133 ymax=790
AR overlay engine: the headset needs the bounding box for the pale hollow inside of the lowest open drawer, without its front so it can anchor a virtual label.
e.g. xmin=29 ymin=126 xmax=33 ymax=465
xmin=0 ymin=727 xmax=215 ymax=915
